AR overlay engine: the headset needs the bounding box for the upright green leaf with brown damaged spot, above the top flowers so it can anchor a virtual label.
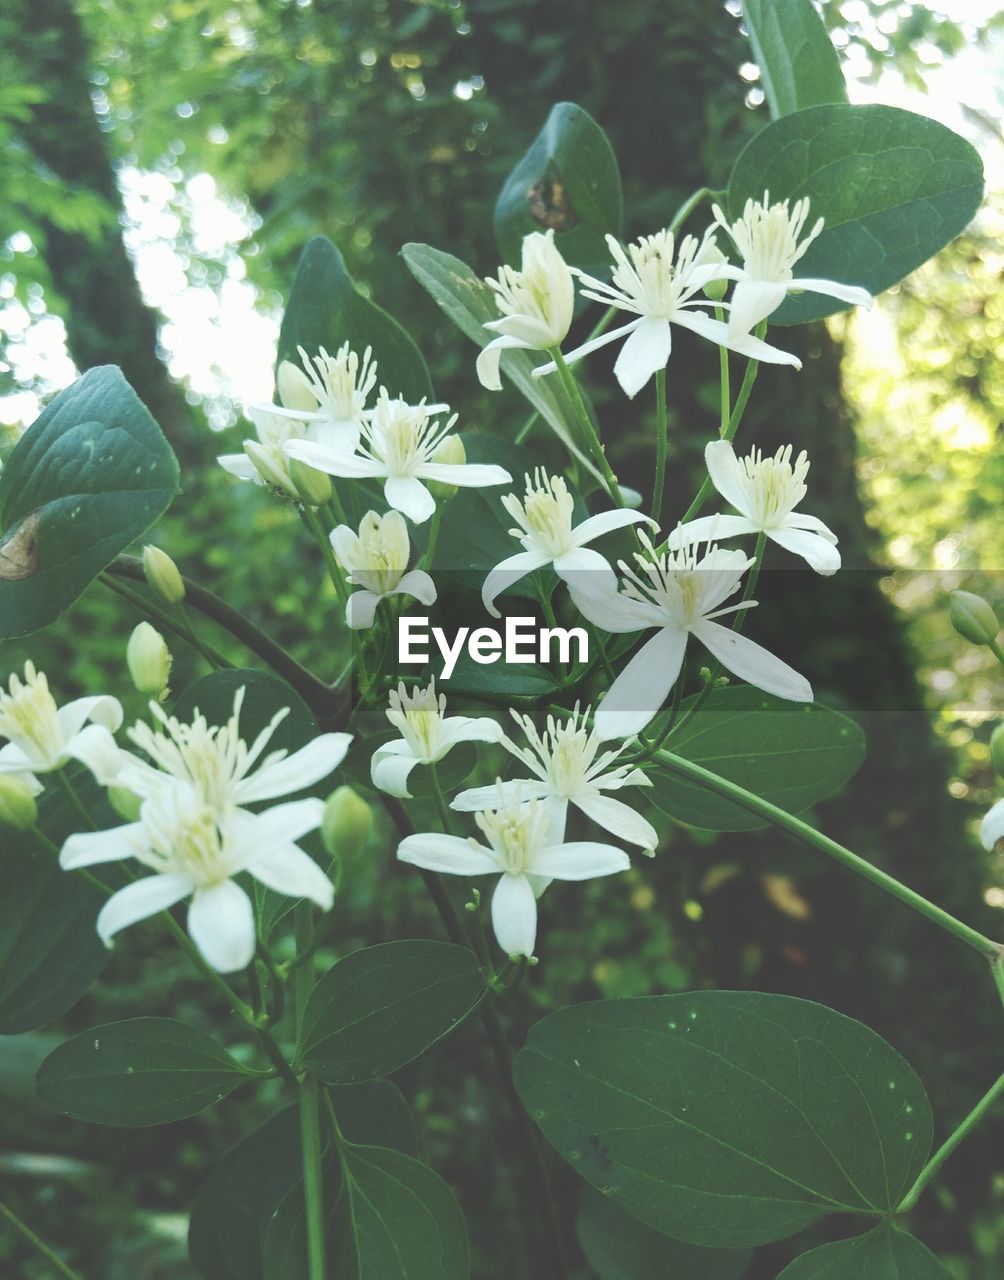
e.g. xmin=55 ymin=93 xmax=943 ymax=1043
xmin=494 ymin=102 xmax=624 ymax=274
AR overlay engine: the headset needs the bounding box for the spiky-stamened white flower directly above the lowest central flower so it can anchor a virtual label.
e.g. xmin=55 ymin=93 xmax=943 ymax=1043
xmin=451 ymin=704 xmax=658 ymax=852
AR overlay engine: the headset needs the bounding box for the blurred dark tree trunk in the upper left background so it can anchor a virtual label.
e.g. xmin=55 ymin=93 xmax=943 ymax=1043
xmin=5 ymin=0 xmax=195 ymax=456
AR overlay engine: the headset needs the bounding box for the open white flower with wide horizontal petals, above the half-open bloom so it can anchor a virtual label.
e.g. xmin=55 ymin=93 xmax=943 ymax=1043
xmin=286 ymin=394 xmax=512 ymax=525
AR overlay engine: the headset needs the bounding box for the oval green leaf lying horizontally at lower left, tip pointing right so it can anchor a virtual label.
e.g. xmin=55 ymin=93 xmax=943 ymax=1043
xmin=37 ymin=1018 xmax=257 ymax=1128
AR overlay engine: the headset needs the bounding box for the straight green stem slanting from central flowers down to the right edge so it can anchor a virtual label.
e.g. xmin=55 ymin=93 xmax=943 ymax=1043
xmin=657 ymin=751 xmax=1000 ymax=959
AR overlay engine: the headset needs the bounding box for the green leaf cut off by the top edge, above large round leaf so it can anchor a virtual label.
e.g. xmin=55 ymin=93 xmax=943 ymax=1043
xmin=743 ymin=0 xmax=846 ymax=120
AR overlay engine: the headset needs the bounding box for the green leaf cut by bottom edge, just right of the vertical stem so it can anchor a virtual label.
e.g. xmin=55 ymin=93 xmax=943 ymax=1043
xmin=333 ymin=1144 xmax=470 ymax=1280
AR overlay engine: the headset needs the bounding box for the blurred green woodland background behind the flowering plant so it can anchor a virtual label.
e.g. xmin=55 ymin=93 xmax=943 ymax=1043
xmin=0 ymin=0 xmax=1004 ymax=1280
